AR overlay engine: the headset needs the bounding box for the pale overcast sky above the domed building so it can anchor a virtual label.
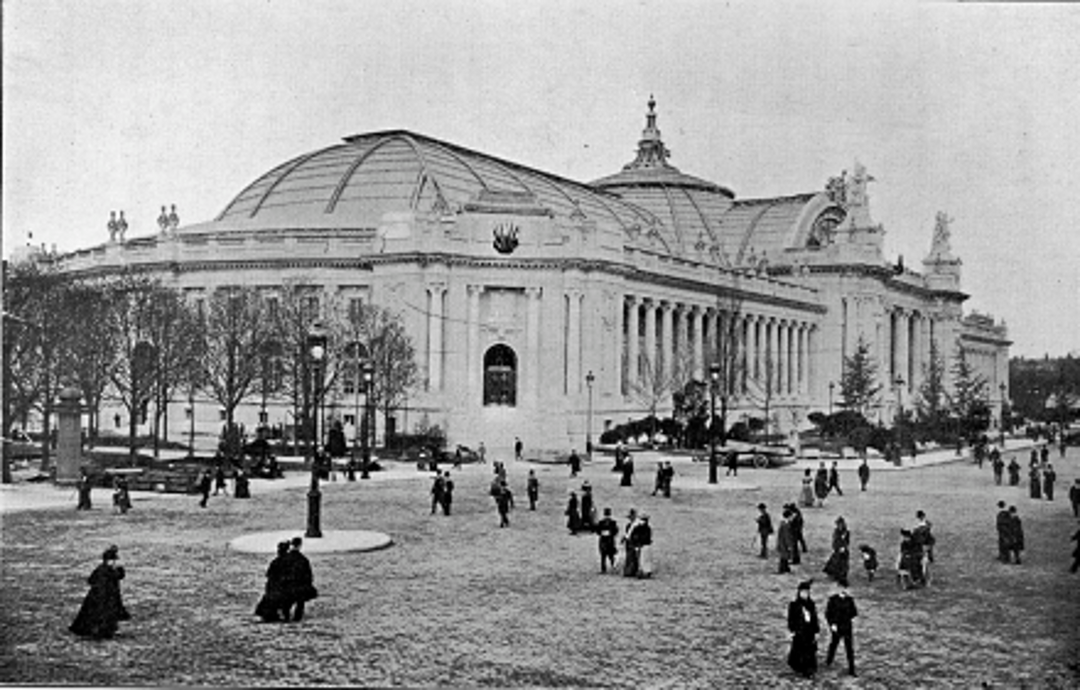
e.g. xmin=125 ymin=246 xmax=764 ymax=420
xmin=3 ymin=0 xmax=1080 ymax=356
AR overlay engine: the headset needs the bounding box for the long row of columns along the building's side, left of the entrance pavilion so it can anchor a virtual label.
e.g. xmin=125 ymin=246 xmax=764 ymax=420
xmin=621 ymin=295 xmax=815 ymax=397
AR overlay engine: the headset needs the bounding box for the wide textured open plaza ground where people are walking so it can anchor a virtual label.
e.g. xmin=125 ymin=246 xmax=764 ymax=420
xmin=0 ymin=448 xmax=1080 ymax=688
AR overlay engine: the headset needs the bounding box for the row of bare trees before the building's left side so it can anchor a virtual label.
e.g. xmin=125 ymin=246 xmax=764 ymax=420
xmin=3 ymin=263 xmax=418 ymax=481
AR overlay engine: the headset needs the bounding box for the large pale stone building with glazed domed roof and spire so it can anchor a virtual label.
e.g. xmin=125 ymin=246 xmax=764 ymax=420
xmin=50 ymin=99 xmax=1009 ymax=450
